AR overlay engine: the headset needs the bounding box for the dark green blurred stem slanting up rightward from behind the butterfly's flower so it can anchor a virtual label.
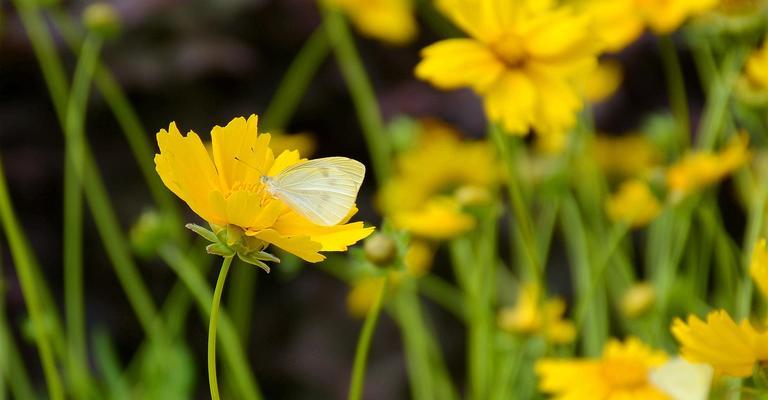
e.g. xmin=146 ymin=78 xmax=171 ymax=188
xmin=264 ymin=25 xmax=330 ymax=131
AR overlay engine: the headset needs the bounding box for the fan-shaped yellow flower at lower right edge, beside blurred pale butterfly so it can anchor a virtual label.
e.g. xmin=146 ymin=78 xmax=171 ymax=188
xmin=672 ymin=310 xmax=768 ymax=377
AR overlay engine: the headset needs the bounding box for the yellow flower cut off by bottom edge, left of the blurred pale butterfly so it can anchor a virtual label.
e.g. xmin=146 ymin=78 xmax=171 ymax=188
xmin=535 ymin=338 xmax=668 ymax=400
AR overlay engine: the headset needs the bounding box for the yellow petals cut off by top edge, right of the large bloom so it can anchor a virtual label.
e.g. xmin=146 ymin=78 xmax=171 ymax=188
xmin=583 ymin=0 xmax=718 ymax=52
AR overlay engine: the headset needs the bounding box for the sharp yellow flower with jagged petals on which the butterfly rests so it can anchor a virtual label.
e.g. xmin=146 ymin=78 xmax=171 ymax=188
xmin=155 ymin=115 xmax=373 ymax=262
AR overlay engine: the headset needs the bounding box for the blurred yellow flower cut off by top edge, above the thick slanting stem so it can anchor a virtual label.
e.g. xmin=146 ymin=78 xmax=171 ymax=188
xmin=326 ymin=0 xmax=417 ymax=45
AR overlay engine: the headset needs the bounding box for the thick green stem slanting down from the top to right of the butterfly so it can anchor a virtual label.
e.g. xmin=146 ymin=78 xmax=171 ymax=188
xmin=323 ymin=8 xmax=391 ymax=184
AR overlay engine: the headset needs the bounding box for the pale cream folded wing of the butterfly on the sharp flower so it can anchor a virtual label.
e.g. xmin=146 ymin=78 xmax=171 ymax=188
xmin=272 ymin=157 xmax=365 ymax=226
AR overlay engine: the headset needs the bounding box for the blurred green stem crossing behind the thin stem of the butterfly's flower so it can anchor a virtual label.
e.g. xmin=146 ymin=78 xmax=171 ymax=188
xmin=160 ymin=246 xmax=262 ymax=400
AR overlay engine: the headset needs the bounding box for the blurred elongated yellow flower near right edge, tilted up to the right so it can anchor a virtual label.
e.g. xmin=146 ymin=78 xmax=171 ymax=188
xmin=667 ymin=133 xmax=750 ymax=195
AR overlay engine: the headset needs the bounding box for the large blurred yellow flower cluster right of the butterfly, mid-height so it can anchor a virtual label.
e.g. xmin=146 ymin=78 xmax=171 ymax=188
xmin=378 ymin=121 xmax=500 ymax=239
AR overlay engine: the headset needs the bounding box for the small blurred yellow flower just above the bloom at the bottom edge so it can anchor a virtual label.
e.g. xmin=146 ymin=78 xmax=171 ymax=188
xmin=498 ymin=284 xmax=576 ymax=343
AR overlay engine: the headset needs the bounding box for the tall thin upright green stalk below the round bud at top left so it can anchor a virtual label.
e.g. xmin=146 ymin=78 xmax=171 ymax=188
xmin=63 ymin=36 xmax=101 ymax=397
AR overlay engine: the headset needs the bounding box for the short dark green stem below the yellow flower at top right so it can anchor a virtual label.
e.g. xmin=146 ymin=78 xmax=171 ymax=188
xmin=659 ymin=36 xmax=691 ymax=151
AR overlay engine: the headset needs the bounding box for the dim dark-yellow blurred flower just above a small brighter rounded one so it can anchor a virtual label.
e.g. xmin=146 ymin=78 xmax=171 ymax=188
xmin=594 ymin=133 xmax=661 ymax=177
